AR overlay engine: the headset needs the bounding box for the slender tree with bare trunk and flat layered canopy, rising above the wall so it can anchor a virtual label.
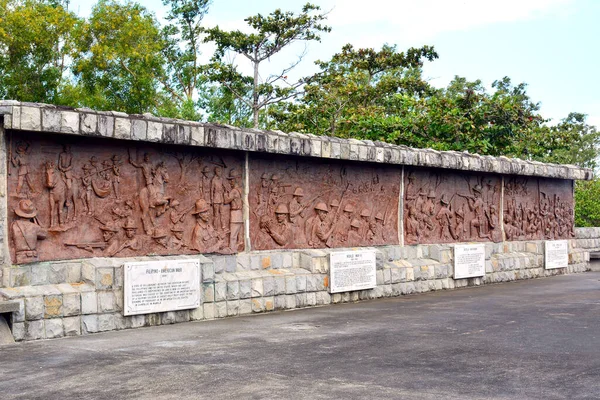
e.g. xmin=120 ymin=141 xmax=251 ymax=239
xmin=206 ymin=3 xmax=330 ymax=128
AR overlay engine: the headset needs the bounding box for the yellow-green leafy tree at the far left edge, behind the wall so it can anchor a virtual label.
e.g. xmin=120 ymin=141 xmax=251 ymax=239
xmin=0 ymin=0 xmax=80 ymax=104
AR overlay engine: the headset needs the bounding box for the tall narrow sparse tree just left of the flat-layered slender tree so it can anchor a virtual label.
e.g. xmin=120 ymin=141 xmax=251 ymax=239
xmin=161 ymin=0 xmax=210 ymax=120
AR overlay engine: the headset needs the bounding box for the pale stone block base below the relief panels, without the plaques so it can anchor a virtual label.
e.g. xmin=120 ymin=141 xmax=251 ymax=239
xmin=0 ymin=236 xmax=600 ymax=341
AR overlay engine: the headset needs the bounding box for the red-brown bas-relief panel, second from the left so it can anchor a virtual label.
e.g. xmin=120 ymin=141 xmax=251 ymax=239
xmin=248 ymin=155 xmax=401 ymax=250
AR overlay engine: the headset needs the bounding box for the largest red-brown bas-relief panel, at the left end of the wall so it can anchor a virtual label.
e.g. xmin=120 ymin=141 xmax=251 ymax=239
xmin=7 ymin=134 xmax=244 ymax=264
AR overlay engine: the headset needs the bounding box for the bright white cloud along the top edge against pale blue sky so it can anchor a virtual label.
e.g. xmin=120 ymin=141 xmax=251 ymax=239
xmin=323 ymin=0 xmax=573 ymax=41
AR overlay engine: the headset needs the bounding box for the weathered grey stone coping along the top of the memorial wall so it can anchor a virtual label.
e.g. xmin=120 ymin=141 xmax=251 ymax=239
xmin=0 ymin=100 xmax=593 ymax=180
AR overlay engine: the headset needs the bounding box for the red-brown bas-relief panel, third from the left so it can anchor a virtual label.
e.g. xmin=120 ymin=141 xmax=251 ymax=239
xmin=404 ymin=168 xmax=502 ymax=245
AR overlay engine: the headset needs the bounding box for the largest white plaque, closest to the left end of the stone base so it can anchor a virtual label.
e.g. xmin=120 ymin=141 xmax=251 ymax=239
xmin=124 ymin=260 xmax=200 ymax=315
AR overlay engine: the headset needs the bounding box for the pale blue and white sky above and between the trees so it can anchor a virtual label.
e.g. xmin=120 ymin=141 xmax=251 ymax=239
xmin=70 ymin=0 xmax=600 ymax=128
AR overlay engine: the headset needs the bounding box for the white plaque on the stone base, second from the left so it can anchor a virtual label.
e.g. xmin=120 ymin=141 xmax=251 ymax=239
xmin=329 ymin=250 xmax=377 ymax=293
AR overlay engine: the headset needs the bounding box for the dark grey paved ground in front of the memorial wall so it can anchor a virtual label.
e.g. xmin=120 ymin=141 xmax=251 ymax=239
xmin=0 ymin=272 xmax=600 ymax=400
